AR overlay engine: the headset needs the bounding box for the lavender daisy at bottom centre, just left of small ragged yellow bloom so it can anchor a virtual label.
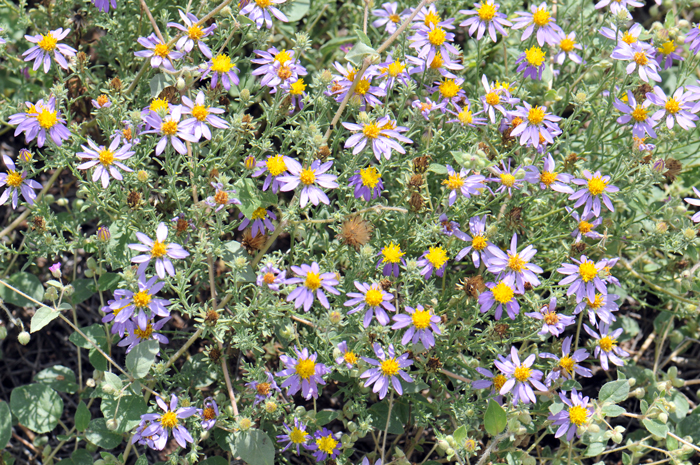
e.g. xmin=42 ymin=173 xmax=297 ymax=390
xmin=275 ymin=347 xmax=331 ymax=400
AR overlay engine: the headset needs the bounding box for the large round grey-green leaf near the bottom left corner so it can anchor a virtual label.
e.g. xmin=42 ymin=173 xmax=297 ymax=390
xmin=10 ymin=383 xmax=63 ymax=434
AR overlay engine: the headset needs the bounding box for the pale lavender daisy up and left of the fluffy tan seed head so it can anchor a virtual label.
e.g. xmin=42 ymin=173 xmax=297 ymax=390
xmin=279 ymin=158 xmax=338 ymax=208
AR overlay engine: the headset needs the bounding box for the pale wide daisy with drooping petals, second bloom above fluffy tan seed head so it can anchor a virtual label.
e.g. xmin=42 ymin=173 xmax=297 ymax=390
xmin=342 ymin=116 xmax=413 ymax=161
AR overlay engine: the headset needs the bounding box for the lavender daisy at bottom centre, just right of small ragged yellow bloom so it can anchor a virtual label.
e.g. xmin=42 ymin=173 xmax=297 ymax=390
xmin=360 ymin=342 xmax=414 ymax=399
